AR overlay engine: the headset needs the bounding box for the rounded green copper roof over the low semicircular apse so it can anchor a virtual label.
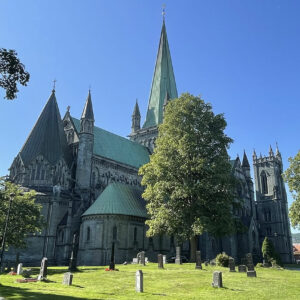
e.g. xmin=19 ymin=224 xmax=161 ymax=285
xmin=82 ymin=183 xmax=147 ymax=218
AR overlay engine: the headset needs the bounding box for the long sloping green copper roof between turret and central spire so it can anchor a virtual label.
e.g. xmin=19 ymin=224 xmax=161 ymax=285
xmin=72 ymin=118 xmax=149 ymax=168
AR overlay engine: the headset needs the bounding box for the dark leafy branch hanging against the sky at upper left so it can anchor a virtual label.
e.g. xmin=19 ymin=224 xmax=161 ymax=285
xmin=0 ymin=48 xmax=30 ymax=100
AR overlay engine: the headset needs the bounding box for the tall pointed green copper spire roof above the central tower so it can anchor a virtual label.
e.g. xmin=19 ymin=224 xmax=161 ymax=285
xmin=143 ymin=21 xmax=178 ymax=128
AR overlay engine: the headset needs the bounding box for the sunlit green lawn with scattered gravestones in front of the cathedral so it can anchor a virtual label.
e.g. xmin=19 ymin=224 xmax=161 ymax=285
xmin=0 ymin=263 xmax=300 ymax=300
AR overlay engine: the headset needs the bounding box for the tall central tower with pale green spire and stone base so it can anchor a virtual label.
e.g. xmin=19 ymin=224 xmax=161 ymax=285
xmin=129 ymin=19 xmax=178 ymax=152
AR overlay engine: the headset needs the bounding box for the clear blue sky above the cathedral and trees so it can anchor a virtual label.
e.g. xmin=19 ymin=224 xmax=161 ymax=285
xmin=0 ymin=0 xmax=300 ymax=232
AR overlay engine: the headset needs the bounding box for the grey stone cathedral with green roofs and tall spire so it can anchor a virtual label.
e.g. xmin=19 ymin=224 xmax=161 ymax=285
xmin=7 ymin=21 xmax=293 ymax=265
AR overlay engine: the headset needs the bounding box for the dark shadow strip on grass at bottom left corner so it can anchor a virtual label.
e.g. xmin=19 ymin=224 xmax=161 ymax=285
xmin=0 ymin=285 xmax=101 ymax=300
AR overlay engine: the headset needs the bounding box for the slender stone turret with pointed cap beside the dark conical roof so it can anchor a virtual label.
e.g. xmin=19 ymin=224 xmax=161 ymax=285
xmin=76 ymin=91 xmax=95 ymax=202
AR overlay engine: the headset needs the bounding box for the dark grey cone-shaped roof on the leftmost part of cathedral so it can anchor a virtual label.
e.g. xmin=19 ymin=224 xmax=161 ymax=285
xmin=20 ymin=90 xmax=70 ymax=165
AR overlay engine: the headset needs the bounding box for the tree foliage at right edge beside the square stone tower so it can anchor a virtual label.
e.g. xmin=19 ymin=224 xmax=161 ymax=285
xmin=283 ymin=151 xmax=300 ymax=229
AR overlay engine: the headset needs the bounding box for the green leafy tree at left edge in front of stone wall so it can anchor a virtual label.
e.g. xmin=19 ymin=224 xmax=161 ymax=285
xmin=0 ymin=178 xmax=43 ymax=248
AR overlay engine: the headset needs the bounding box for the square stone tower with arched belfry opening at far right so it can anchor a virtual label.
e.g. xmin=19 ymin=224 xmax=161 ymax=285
xmin=253 ymin=146 xmax=293 ymax=263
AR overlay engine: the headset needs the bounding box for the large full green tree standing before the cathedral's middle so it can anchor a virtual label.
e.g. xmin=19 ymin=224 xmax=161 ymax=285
xmin=139 ymin=93 xmax=239 ymax=259
